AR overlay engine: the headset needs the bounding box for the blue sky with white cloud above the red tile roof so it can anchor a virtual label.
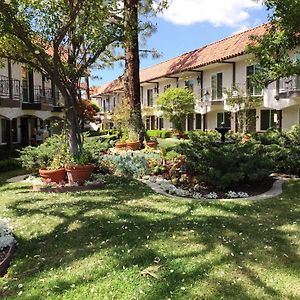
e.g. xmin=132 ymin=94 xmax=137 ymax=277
xmin=91 ymin=0 xmax=268 ymax=86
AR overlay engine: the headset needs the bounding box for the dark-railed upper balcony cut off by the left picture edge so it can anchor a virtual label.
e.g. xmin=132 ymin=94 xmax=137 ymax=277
xmin=0 ymin=75 xmax=20 ymax=107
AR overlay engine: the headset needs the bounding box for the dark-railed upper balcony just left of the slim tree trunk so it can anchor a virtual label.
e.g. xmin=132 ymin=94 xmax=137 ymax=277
xmin=22 ymin=85 xmax=63 ymax=112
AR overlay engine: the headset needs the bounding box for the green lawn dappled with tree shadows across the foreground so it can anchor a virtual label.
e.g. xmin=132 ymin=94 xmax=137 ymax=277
xmin=0 ymin=171 xmax=300 ymax=300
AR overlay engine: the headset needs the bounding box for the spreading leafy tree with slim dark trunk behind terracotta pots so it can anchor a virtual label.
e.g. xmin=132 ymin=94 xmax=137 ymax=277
xmin=0 ymin=0 xmax=123 ymax=156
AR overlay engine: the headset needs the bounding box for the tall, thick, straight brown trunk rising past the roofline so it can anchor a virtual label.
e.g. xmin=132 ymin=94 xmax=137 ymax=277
xmin=124 ymin=0 xmax=145 ymax=144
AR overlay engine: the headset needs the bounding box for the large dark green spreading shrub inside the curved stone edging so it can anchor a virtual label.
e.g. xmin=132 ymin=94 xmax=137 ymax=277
xmin=178 ymin=133 xmax=273 ymax=189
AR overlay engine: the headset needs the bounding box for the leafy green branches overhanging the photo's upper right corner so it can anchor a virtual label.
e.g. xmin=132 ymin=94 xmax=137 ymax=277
xmin=249 ymin=0 xmax=300 ymax=88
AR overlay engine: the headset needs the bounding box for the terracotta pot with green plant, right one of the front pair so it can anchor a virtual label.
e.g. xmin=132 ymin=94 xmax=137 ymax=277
xmin=66 ymin=150 xmax=95 ymax=185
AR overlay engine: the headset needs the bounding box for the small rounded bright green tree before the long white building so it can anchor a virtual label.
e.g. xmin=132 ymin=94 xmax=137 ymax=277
xmin=156 ymin=88 xmax=195 ymax=133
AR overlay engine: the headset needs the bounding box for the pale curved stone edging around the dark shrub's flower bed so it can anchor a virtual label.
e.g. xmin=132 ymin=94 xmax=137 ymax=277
xmin=141 ymin=179 xmax=288 ymax=202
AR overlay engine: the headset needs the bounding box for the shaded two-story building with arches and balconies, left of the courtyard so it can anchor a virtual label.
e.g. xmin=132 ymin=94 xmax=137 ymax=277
xmin=0 ymin=59 xmax=63 ymax=150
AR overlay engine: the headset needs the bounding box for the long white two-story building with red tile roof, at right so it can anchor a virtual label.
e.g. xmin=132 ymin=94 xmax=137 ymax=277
xmin=96 ymin=25 xmax=300 ymax=131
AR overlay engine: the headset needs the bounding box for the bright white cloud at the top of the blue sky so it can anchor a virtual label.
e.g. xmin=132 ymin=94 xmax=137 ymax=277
xmin=160 ymin=0 xmax=262 ymax=28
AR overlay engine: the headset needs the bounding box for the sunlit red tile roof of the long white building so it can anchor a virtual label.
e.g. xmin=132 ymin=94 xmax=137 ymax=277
xmin=98 ymin=24 xmax=270 ymax=94
